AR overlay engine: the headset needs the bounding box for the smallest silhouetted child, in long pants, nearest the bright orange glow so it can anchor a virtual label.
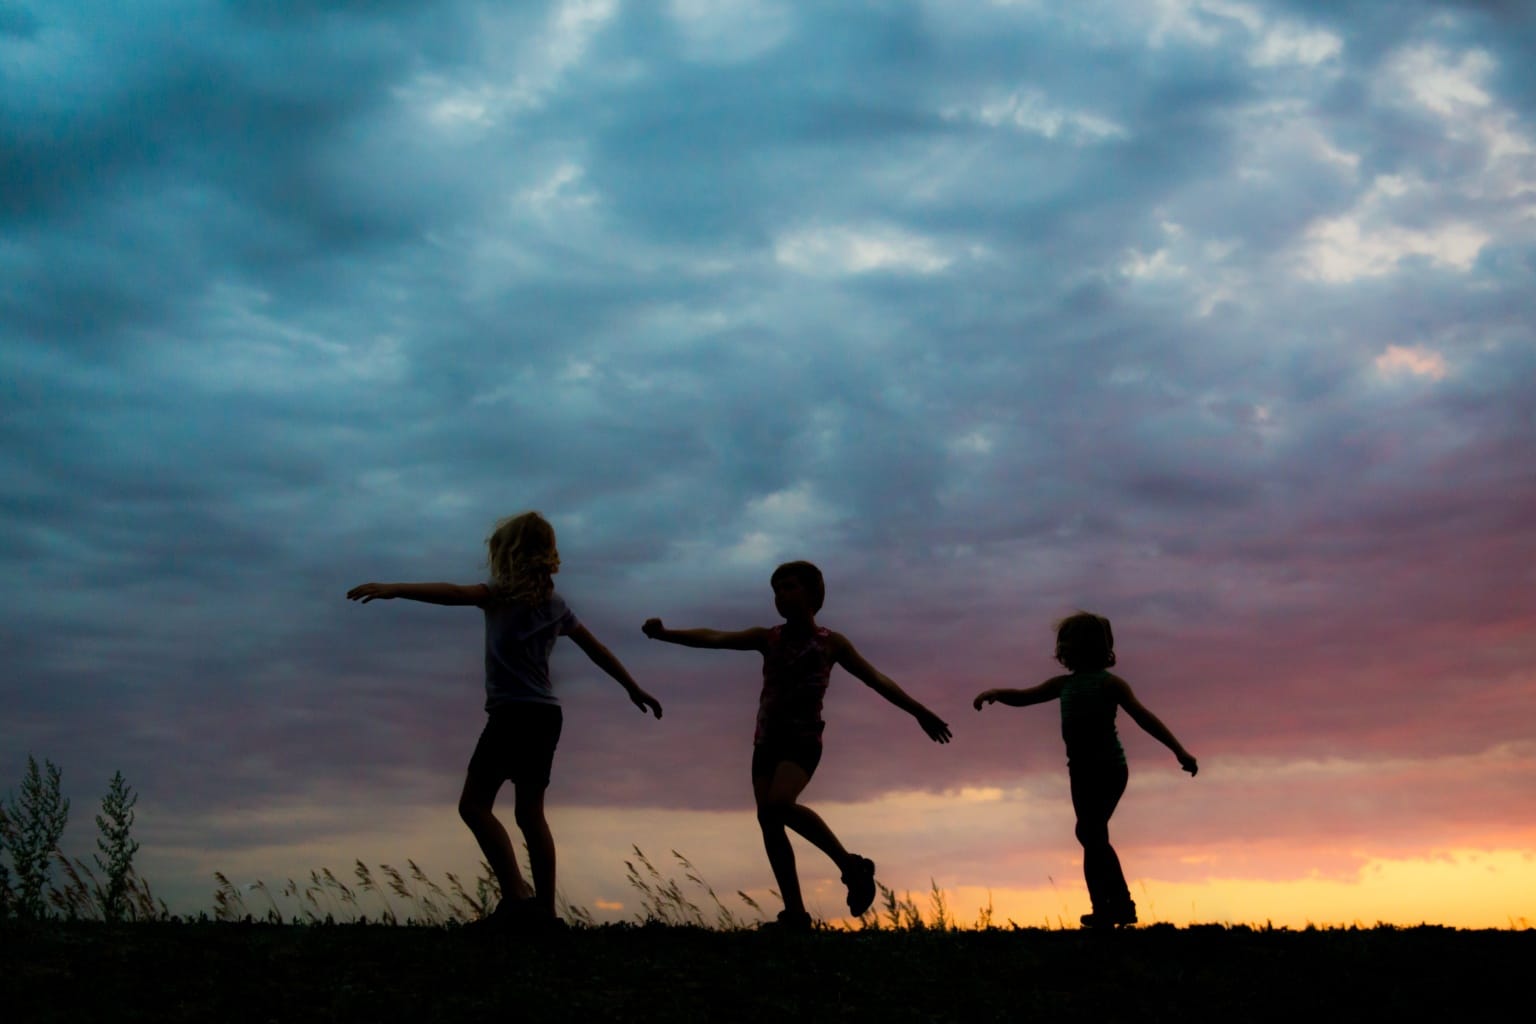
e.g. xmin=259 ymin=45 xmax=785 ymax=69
xmin=975 ymin=611 xmax=1198 ymax=927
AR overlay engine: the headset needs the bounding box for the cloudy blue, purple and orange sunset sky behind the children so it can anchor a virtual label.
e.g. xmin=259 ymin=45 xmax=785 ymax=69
xmin=0 ymin=0 xmax=1536 ymax=927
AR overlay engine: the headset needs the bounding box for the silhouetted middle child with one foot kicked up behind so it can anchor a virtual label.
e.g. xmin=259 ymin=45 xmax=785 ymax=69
xmin=642 ymin=562 xmax=949 ymax=930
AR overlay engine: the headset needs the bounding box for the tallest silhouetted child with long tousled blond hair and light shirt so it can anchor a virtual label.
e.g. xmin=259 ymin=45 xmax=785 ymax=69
xmin=347 ymin=511 xmax=662 ymax=930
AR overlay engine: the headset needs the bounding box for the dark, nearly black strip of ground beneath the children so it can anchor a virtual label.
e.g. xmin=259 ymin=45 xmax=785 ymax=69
xmin=0 ymin=923 xmax=1536 ymax=1024
